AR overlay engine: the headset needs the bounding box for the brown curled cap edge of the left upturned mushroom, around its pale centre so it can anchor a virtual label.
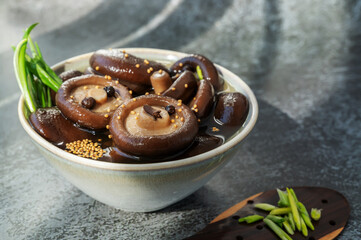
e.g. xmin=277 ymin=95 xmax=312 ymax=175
xmin=56 ymin=75 xmax=131 ymax=130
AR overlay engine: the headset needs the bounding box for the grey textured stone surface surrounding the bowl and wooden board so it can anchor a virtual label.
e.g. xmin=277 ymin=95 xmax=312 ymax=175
xmin=0 ymin=0 xmax=361 ymax=239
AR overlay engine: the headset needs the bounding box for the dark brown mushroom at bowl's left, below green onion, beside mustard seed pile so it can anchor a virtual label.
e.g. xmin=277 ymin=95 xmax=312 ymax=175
xmin=29 ymin=107 xmax=94 ymax=147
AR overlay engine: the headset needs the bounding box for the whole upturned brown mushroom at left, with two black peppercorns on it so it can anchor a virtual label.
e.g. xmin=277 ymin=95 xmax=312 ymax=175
xmin=56 ymin=75 xmax=131 ymax=129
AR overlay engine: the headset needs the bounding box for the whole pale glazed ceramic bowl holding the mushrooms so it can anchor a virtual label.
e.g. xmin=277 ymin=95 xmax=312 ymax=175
xmin=18 ymin=48 xmax=258 ymax=212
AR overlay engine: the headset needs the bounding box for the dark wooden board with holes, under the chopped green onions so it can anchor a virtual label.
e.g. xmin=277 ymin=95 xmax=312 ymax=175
xmin=187 ymin=187 xmax=350 ymax=240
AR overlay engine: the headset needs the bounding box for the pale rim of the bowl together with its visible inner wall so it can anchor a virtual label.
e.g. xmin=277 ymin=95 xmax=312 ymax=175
xmin=18 ymin=48 xmax=258 ymax=171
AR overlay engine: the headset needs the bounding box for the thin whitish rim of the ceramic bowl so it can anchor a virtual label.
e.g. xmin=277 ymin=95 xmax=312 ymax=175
xmin=18 ymin=48 xmax=258 ymax=171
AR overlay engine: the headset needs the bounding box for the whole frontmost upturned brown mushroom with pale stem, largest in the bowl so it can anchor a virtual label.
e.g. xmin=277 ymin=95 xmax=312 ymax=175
xmin=110 ymin=95 xmax=198 ymax=157
